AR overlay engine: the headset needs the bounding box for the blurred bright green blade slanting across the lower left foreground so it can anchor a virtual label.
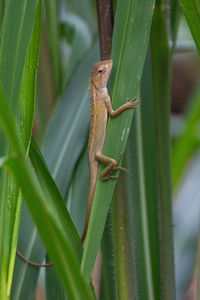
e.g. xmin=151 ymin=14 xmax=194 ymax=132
xmin=1 ymin=158 xmax=94 ymax=299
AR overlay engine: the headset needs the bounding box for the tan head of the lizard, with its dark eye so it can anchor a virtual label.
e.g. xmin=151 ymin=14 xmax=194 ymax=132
xmin=92 ymin=59 xmax=112 ymax=89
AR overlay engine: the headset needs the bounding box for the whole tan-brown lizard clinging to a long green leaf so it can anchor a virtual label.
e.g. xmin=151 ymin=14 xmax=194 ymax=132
xmin=81 ymin=59 xmax=139 ymax=242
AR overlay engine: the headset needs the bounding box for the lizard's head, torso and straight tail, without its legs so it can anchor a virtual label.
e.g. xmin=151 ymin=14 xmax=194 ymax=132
xmin=81 ymin=60 xmax=112 ymax=242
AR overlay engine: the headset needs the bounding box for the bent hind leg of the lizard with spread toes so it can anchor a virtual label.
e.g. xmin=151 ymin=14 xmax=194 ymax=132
xmin=95 ymin=153 xmax=130 ymax=180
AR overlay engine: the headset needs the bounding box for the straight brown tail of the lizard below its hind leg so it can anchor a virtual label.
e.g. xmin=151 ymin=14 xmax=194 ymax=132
xmin=81 ymin=176 xmax=96 ymax=244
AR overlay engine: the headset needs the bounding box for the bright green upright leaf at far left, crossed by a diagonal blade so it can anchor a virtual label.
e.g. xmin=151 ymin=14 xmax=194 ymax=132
xmin=0 ymin=0 xmax=41 ymax=295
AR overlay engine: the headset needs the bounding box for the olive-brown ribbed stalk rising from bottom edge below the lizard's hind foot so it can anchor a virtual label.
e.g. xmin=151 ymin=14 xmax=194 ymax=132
xmin=112 ymin=179 xmax=135 ymax=300
